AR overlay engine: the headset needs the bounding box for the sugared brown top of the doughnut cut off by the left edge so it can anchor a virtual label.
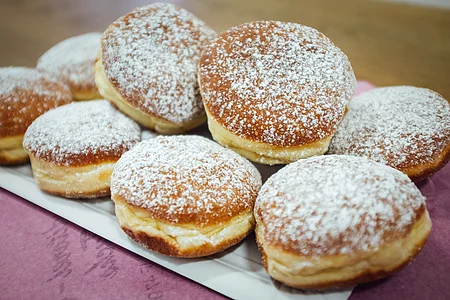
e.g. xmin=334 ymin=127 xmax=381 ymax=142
xmin=0 ymin=67 xmax=72 ymax=137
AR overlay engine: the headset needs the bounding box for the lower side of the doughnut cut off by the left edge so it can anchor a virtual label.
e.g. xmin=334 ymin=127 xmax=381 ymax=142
xmin=0 ymin=135 xmax=28 ymax=165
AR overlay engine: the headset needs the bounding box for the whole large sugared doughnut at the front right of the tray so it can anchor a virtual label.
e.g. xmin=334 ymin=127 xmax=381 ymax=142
xmin=255 ymin=155 xmax=431 ymax=289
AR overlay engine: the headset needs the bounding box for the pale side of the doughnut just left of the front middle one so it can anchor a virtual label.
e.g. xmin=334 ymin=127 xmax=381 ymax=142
xmin=29 ymin=154 xmax=116 ymax=198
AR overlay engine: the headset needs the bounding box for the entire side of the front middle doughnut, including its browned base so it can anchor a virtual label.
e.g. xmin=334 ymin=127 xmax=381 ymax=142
xmin=112 ymin=194 xmax=255 ymax=258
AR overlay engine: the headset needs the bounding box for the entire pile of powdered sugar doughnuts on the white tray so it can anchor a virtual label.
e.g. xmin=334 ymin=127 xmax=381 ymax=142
xmin=0 ymin=3 xmax=450 ymax=289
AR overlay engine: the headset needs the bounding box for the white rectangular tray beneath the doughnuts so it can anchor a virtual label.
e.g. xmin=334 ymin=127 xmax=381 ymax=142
xmin=0 ymin=158 xmax=352 ymax=300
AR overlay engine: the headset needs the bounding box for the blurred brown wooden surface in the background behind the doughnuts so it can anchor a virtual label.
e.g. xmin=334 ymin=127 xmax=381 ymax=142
xmin=0 ymin=0 xmax=450 ymax=100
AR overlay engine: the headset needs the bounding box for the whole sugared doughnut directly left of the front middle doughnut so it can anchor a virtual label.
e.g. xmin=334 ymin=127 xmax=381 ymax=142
xmin=23 ymin=100 xmax=141 ymax=198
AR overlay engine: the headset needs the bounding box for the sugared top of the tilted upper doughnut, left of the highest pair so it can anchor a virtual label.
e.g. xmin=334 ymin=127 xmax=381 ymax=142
xmin=101 ymin=3 xmax=216 ymax=124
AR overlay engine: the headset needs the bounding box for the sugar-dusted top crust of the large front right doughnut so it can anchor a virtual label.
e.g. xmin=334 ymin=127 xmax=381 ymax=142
xmin=255 ymin=155 xmax=425 ymax=256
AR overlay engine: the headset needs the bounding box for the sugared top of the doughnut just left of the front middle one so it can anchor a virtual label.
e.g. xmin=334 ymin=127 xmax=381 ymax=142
xmin=23 ymin=100 xmax=141 ymax=166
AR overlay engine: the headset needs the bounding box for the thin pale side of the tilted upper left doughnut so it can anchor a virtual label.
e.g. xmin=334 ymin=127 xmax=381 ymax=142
xmin=95 ymin=51 xmax=205 ymax=134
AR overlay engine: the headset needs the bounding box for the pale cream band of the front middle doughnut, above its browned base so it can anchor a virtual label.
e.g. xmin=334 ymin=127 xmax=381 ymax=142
xmin=112 ymin=195 xmax=255 ymax=252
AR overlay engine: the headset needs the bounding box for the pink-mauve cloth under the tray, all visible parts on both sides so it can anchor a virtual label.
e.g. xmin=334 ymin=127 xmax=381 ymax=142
xmin=0 ymin=83 xmax=450 ymax=300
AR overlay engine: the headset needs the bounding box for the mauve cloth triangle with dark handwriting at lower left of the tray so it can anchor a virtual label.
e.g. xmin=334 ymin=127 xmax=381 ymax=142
xmin=0 ymin=189 xmax=224 ymax=300
